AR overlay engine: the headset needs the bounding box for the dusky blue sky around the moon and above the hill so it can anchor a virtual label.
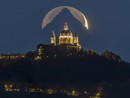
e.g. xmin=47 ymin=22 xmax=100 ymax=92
xmin=0 ymin=0 xmax=130 ymax=62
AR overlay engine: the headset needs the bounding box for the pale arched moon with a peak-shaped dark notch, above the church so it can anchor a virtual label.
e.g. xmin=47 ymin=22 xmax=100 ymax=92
xmin=42 ymin=6 xmax=89 ymax=30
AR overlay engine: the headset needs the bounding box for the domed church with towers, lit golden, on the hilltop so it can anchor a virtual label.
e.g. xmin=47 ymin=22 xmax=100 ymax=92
xmin=35 ymin=22 xmax=81 ymax=60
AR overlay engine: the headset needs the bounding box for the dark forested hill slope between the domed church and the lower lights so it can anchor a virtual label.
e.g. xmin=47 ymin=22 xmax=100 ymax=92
xmin=0 ymin=50 xmax=130 ymax=85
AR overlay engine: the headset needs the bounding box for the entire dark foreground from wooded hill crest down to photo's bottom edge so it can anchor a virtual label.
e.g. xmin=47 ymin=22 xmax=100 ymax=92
xmin=0 ymin=51 xmax=130 ymax=98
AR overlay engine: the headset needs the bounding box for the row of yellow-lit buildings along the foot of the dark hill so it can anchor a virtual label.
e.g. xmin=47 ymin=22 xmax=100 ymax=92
xmin=0 ymin=83 xmax=102 ymax=98
